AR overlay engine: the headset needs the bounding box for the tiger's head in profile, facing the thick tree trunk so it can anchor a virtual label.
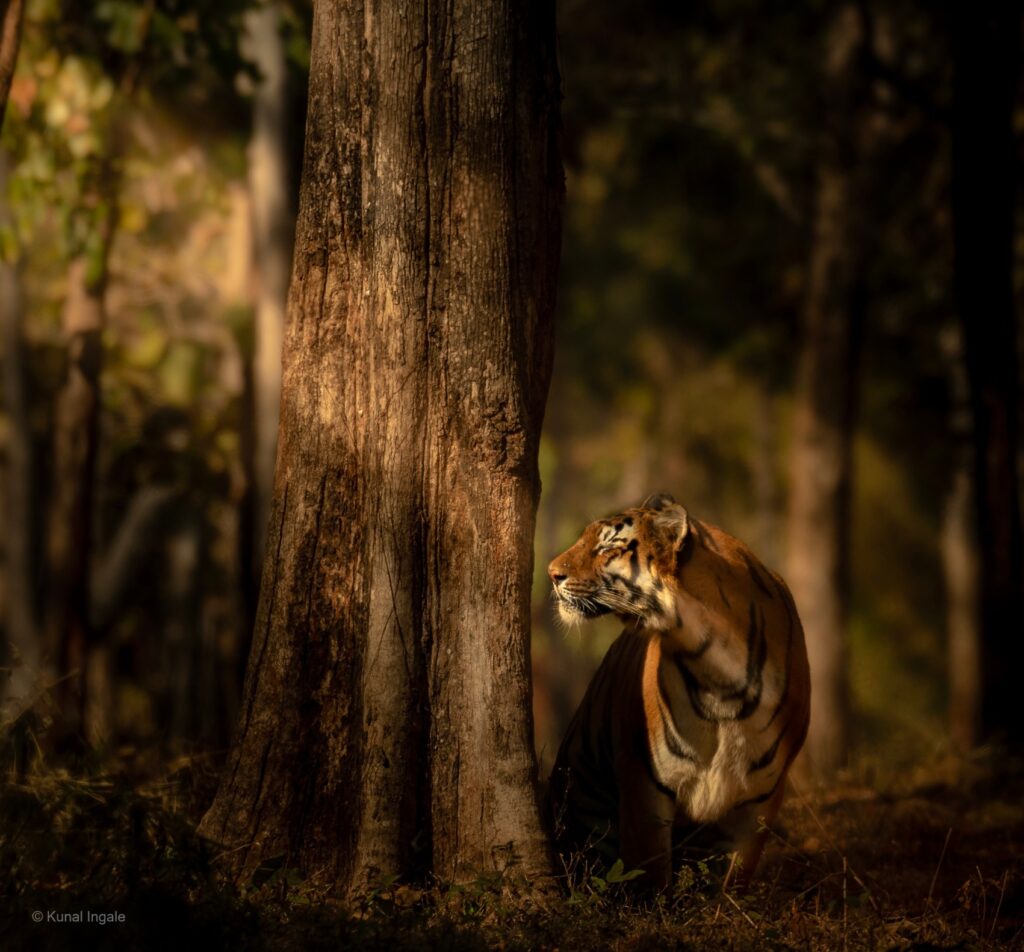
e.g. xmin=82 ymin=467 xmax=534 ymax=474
xmin=548 ymin=493 xmax=690 ymax=631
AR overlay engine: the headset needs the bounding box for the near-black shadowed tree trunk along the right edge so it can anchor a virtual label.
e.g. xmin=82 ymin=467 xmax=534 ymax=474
xmin=952 ymin=2 xmax=1024 ymax=742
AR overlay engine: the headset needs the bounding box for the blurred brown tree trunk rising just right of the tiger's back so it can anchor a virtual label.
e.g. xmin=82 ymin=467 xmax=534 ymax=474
xmin=787 ymin=5 xmax=863 ymax=777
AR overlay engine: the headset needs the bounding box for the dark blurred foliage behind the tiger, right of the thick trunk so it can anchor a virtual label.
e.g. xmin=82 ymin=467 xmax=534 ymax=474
xmin=535 ymin=0 xmax=974 ymax=760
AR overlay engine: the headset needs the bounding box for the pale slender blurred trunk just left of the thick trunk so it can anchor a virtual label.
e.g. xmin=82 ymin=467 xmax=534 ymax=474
xmin=246 ymin=4 xmax=295 ymax=565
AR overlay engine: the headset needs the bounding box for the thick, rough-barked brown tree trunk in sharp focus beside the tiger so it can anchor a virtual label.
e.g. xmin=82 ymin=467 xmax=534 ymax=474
xmin=201 ymin=0 xmax=562 ymax=889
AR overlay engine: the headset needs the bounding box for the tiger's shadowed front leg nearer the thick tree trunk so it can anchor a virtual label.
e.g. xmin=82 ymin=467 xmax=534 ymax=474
xmin=617 ymin=758 xmax=676 ymax=891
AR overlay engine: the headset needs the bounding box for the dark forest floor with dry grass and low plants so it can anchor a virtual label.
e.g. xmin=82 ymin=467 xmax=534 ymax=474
xmin=0 ymin=753 xmax=1024 ymax=952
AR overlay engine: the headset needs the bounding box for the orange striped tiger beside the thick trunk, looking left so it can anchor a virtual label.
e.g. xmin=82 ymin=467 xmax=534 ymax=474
xmin=548 ymin=493 xmax=810 ymax=891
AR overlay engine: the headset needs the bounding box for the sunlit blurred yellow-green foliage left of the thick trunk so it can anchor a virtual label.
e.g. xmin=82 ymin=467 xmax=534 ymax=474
xmin=0 ymin=0 xmax=309 ymax=744
